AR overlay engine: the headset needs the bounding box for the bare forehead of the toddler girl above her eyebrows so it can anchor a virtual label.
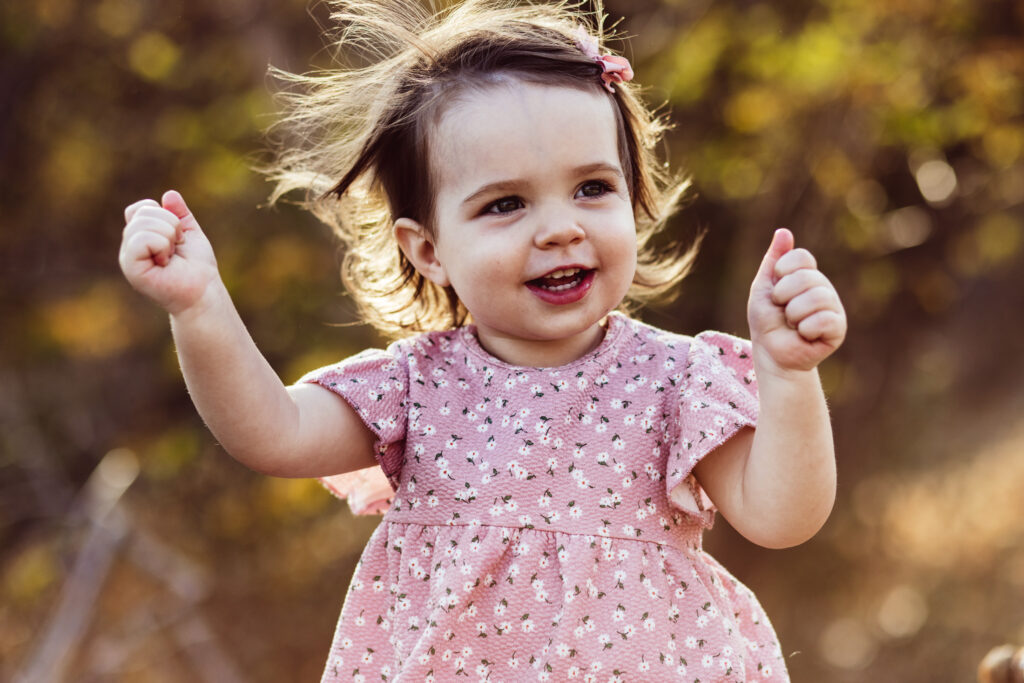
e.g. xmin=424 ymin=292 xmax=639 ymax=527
xmin=430 ymin=80 xmax=621 ymax=196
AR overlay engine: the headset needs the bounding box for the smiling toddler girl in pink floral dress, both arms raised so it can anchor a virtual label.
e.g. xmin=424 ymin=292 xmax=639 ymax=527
xmin=121 ymin=2 xmax=846 ymax=683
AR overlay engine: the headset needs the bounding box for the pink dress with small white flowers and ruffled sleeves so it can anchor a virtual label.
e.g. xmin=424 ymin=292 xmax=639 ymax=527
xmin=303 ymin=313 xmax=788 ymax=683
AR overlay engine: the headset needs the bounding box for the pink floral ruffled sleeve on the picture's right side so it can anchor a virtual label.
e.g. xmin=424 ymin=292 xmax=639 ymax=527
xmin=666 ymin=332 xmax=758 ymax=526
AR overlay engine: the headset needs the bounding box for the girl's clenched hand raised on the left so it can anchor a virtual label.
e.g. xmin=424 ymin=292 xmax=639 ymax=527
xmin=118 ymin=189 xmax=220 ymax=315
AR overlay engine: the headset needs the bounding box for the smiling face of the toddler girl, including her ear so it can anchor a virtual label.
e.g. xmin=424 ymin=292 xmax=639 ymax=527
xmin=403 ymin=80 xmax=636 ymax=367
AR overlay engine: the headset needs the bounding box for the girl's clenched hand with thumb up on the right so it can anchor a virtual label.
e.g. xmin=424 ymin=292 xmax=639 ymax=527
xmin=746 ymin=228 xmax=846 ymax=371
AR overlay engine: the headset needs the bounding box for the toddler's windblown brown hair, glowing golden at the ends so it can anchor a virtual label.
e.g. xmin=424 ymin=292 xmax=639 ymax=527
xmin=266 ymin=0 xmax=697 ymax=336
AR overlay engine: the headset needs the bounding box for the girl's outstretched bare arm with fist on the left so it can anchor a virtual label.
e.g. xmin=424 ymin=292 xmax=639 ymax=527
xmin=119 ymin=190 xmax=374 ymax=477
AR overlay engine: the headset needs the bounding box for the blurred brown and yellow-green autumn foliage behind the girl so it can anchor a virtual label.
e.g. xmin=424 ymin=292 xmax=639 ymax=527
xmin=0 ymin=0 xmax=1024 ymax=683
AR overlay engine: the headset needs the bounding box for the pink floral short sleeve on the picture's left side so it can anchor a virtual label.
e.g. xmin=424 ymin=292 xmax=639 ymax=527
xmin=299 ymin=345 xmax=409 ymax=514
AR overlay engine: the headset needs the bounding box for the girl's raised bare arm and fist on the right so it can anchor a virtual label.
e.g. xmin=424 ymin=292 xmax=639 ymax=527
xmin=694 ymin=229 xmax=846 ymax=548
